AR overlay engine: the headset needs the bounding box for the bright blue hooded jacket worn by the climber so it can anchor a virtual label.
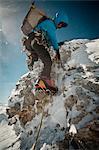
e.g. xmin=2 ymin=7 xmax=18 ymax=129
xmin=32 ymin=12 xmax=68 ymax=52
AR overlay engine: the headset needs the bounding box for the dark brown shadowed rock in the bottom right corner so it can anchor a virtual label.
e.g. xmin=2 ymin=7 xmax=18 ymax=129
xmin=58 ymin=120 xmax=99 ymax=150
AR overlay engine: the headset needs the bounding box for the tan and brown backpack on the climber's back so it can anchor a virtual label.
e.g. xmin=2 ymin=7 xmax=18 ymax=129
xmin=21 ymin=4 xmax=47 ymax=35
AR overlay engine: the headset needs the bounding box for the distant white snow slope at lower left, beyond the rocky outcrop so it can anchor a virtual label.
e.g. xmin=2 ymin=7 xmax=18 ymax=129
xmin=0 ymin=105 xmax=20 ymax=150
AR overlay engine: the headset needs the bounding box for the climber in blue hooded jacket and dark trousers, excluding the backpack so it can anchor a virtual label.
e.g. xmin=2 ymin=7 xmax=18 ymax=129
xmin=23 ymin=4 xmax=68 ymax=90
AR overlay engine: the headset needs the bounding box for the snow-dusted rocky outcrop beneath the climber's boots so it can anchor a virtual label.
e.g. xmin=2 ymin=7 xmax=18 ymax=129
xmin=2 ymin=39 xmax=99 ymax=150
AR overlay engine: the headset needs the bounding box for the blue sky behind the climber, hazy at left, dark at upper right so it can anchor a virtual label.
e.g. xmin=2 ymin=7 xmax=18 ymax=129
xmin=0 ymin=0 xmax=99 ymax=103
